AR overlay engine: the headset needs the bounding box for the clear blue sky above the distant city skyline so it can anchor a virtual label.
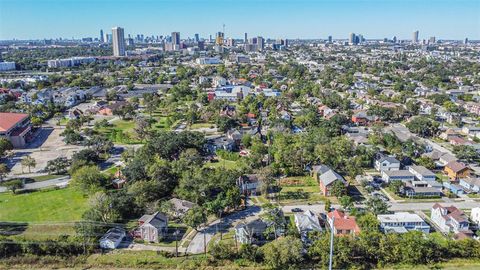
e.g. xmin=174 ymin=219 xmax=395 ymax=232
xmin=0 ymin=0 xmax=480 ymax=40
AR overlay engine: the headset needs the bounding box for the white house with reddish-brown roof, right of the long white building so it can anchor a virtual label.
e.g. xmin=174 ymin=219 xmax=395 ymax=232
xmin=430 ymin=203 xmax=469 ymax=233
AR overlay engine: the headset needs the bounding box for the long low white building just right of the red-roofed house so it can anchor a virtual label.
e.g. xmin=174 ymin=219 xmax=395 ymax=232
xmin=377 ymin=212 xmax=430 ymax=233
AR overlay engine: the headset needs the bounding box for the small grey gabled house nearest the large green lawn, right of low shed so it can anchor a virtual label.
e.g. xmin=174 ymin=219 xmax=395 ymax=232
xmin=135 ymin=212 xmax=168 ymax=243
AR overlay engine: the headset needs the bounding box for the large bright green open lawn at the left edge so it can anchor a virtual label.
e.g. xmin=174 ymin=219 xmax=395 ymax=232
xmin=0 ymin=188 xmax=87 ymax=223
